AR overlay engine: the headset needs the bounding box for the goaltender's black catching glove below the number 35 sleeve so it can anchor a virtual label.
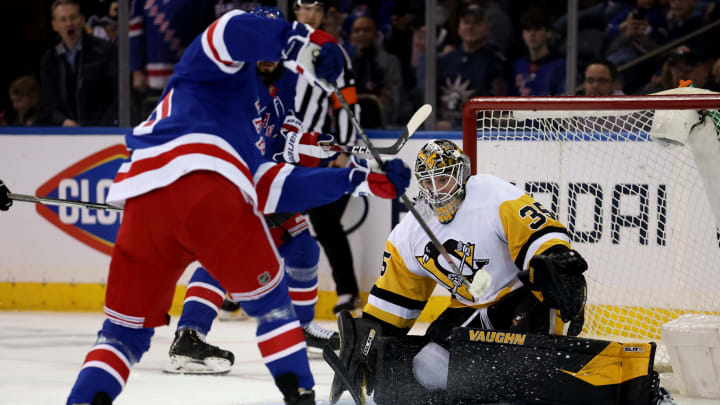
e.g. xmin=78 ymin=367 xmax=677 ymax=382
xmin=518 ymin=247 xmax=588 ymax=322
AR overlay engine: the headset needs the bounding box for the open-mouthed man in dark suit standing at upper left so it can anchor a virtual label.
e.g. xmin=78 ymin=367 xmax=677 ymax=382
xmin=40 ymin=0 xmax=118 ymax=126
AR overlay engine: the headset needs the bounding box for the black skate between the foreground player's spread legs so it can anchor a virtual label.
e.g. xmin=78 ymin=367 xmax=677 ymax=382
xmin=164 ymin=329 xmax=235 ymax=375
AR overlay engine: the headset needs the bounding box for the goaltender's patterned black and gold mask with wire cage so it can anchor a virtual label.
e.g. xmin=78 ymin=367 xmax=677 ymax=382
xmin=415 ymin=139 xmax=470 ymax=224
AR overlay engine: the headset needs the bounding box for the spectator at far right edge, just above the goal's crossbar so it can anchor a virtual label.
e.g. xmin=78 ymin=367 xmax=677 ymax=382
xmin=667 ymin=48 xmax=720 ymax=92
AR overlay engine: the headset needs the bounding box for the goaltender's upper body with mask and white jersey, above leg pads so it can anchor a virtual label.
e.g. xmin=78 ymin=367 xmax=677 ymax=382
xmin=363 ymin=140 xmax=586 ymax=343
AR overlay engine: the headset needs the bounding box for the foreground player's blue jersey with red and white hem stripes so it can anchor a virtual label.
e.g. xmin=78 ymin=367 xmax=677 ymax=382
xmin=107 ymin=10 xmax=353 ymax=214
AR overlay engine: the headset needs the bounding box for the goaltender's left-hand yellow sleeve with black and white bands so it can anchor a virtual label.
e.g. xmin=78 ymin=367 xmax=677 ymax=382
xmin=363 ymin=240 xmax=435 ymax=328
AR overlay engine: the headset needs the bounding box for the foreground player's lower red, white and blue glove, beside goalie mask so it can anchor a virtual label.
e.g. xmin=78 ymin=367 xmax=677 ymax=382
xmin=348 ymin=156 xmax=411 ymax=199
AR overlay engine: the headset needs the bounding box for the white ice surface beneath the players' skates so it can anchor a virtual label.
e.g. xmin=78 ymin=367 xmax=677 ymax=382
xmin=0 ymin=311 xmax=720 ymax=405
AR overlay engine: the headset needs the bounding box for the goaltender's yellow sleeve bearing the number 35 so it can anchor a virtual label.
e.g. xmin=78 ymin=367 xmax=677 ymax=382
xmin=499 ymin=194 xmax=570 ymax=270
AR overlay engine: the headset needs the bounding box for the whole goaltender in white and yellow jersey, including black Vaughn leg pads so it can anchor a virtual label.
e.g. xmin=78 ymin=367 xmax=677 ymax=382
xmin=324 ymin=140 xmax=673 ymax=405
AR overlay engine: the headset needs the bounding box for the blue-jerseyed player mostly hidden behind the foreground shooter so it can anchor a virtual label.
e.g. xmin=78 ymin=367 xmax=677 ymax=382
xmin=160 ymin=6 xmax=354 ymax=375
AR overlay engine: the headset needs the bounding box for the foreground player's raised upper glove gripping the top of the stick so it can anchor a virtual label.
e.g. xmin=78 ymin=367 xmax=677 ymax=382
xmin=282 ymin=21 xmax=344 ymax=93
